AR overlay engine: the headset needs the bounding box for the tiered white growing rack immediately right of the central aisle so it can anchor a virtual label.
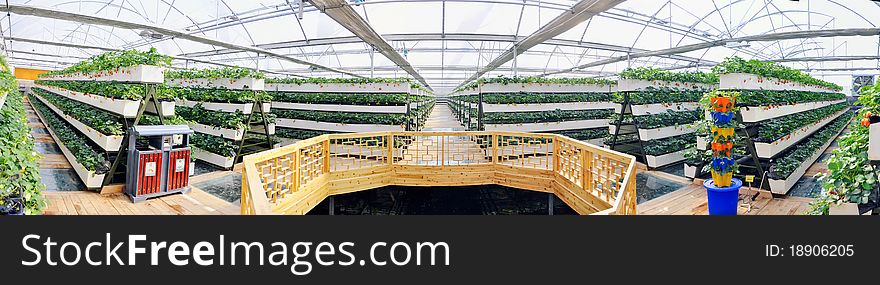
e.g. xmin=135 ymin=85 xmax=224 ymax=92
xmin=450 ymin=78 xmax=616 ymax=142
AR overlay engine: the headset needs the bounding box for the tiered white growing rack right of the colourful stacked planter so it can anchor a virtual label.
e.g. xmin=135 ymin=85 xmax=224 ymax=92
xmin=716 ymin=66 xmax=852 ymax=194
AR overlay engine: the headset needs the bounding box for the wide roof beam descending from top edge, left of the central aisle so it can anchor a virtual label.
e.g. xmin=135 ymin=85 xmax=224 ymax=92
xmin=308 ymin=0 xmax=434 ymax=91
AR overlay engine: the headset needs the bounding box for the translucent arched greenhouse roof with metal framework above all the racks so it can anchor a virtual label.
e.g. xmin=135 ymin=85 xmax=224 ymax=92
xmin=0 ymin=0 xmax=880 ymax=93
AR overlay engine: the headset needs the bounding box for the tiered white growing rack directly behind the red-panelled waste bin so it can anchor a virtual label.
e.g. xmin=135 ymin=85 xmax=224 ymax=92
xmin=31 ymin=65 xmax=174 ymax=189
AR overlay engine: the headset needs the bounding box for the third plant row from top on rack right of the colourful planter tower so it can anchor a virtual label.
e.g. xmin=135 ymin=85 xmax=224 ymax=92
xmin=754 ymin=102 xmax=849 ymax=142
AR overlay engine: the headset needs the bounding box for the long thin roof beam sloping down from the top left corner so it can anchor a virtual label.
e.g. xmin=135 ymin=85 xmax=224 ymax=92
xmin=0 ymin=4 xmax=363 ymax=77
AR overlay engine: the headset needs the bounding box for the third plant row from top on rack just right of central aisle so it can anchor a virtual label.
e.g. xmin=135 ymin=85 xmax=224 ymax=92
xmin=483 ymin=109 xmax=614 ymax=124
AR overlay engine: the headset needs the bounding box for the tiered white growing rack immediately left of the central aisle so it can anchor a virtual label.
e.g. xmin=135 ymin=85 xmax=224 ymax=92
xmin=266 ymin=78 xmax=434 ymax=144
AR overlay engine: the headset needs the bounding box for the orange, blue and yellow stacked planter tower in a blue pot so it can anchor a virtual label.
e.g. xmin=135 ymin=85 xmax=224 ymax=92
xmin=703 ymin=90 xmax=742 ymax=215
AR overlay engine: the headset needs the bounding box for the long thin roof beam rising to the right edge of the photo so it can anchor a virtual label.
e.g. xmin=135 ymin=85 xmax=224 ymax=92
xmin=541 ymin=28 xmax=880 ymax=76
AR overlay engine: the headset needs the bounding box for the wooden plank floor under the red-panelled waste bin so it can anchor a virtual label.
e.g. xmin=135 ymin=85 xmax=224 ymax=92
xmin=44 ymin=188 xmax=241 ymax=215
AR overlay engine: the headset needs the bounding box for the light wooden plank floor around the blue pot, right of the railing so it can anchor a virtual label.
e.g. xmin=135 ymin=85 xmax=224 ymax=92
xmin=637 ymin=181 xmax=813 ymax=215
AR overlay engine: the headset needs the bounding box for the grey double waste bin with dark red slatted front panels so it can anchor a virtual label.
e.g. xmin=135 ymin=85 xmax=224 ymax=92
xmin=125 ymin=125 xmax=193 ymax=202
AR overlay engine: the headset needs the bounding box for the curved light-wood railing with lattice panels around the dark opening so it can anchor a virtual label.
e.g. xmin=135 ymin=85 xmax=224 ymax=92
xmin=242 ymin=132 xmax=636 ymax=214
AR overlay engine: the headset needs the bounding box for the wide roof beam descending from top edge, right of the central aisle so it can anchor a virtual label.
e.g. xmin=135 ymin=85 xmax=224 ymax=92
xmin=459 ymin=0 xmax=623 ymax=89
